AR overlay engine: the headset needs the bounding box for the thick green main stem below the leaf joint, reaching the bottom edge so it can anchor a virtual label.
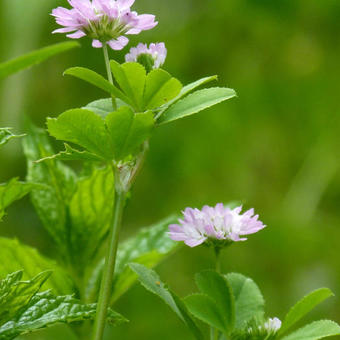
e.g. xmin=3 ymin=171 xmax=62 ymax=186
xmin=93 ymin=175 xmax=125 ymax=340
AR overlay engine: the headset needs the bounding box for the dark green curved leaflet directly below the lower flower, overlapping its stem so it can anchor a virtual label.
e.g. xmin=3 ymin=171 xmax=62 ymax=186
xmin=195 ymin=270 xmax=235 ymax=333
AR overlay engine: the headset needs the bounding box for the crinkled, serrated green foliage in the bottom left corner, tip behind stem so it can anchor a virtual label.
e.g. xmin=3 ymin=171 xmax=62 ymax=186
xmin=0 ymin=272 xmax=127 ymax=340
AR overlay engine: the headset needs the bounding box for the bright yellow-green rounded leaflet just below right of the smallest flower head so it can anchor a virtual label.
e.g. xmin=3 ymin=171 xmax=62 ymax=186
xmin=143 ymin=69 xmax=182 ymax=110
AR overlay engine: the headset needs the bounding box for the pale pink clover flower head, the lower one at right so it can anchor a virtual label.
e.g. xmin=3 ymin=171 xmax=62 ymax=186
xmin=169 ymin=203 xmax=265 ymax=247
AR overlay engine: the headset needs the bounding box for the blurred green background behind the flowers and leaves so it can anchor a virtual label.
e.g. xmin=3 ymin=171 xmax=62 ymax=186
xmin=0 ymin=0 xmax=340 ymax=340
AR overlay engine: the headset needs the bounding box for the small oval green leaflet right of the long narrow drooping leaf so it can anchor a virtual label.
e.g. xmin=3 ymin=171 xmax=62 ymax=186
xmin=184 ymin=294 xmax=228 ymax=333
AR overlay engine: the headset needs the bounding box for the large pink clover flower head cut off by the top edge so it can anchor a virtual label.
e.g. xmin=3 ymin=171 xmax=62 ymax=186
xmin=52 ymin=0 xmax=157 ymax=50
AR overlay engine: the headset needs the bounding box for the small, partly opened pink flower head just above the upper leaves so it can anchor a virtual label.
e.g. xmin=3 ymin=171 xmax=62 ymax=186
xmin=125 ymin=43 xmax=167 ymax=69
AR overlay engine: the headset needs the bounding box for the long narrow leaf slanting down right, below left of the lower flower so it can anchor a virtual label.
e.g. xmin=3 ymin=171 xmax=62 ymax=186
xmin=129 ymin=263 xmax=203 ymax=340
